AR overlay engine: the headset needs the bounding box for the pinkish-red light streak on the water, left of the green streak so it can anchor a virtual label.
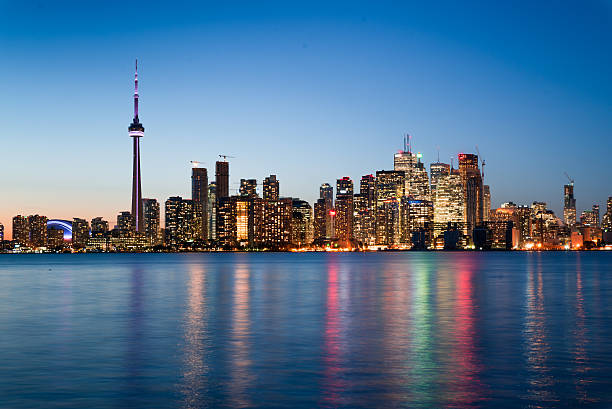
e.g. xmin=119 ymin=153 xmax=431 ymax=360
xmin=323 ymin=263 xmax=346 ymax=407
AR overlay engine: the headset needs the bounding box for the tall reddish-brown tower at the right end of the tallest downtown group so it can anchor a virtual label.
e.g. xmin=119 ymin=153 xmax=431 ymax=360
xmin=459 ymin=153 xmax=484 ymax=235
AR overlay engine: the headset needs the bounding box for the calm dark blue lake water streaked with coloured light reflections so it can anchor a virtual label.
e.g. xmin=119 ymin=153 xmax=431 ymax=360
xmin=0 ymin=252 xmax=612 ymax=408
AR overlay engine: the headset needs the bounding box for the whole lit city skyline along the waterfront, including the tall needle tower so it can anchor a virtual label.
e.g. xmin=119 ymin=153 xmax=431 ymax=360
xmin=4 ymin=67 xmax=612 ymax=251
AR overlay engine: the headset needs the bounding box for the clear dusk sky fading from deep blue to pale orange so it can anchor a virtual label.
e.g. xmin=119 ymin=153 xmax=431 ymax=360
xmin=0 ymin=0 xmax=612 ymax=226
